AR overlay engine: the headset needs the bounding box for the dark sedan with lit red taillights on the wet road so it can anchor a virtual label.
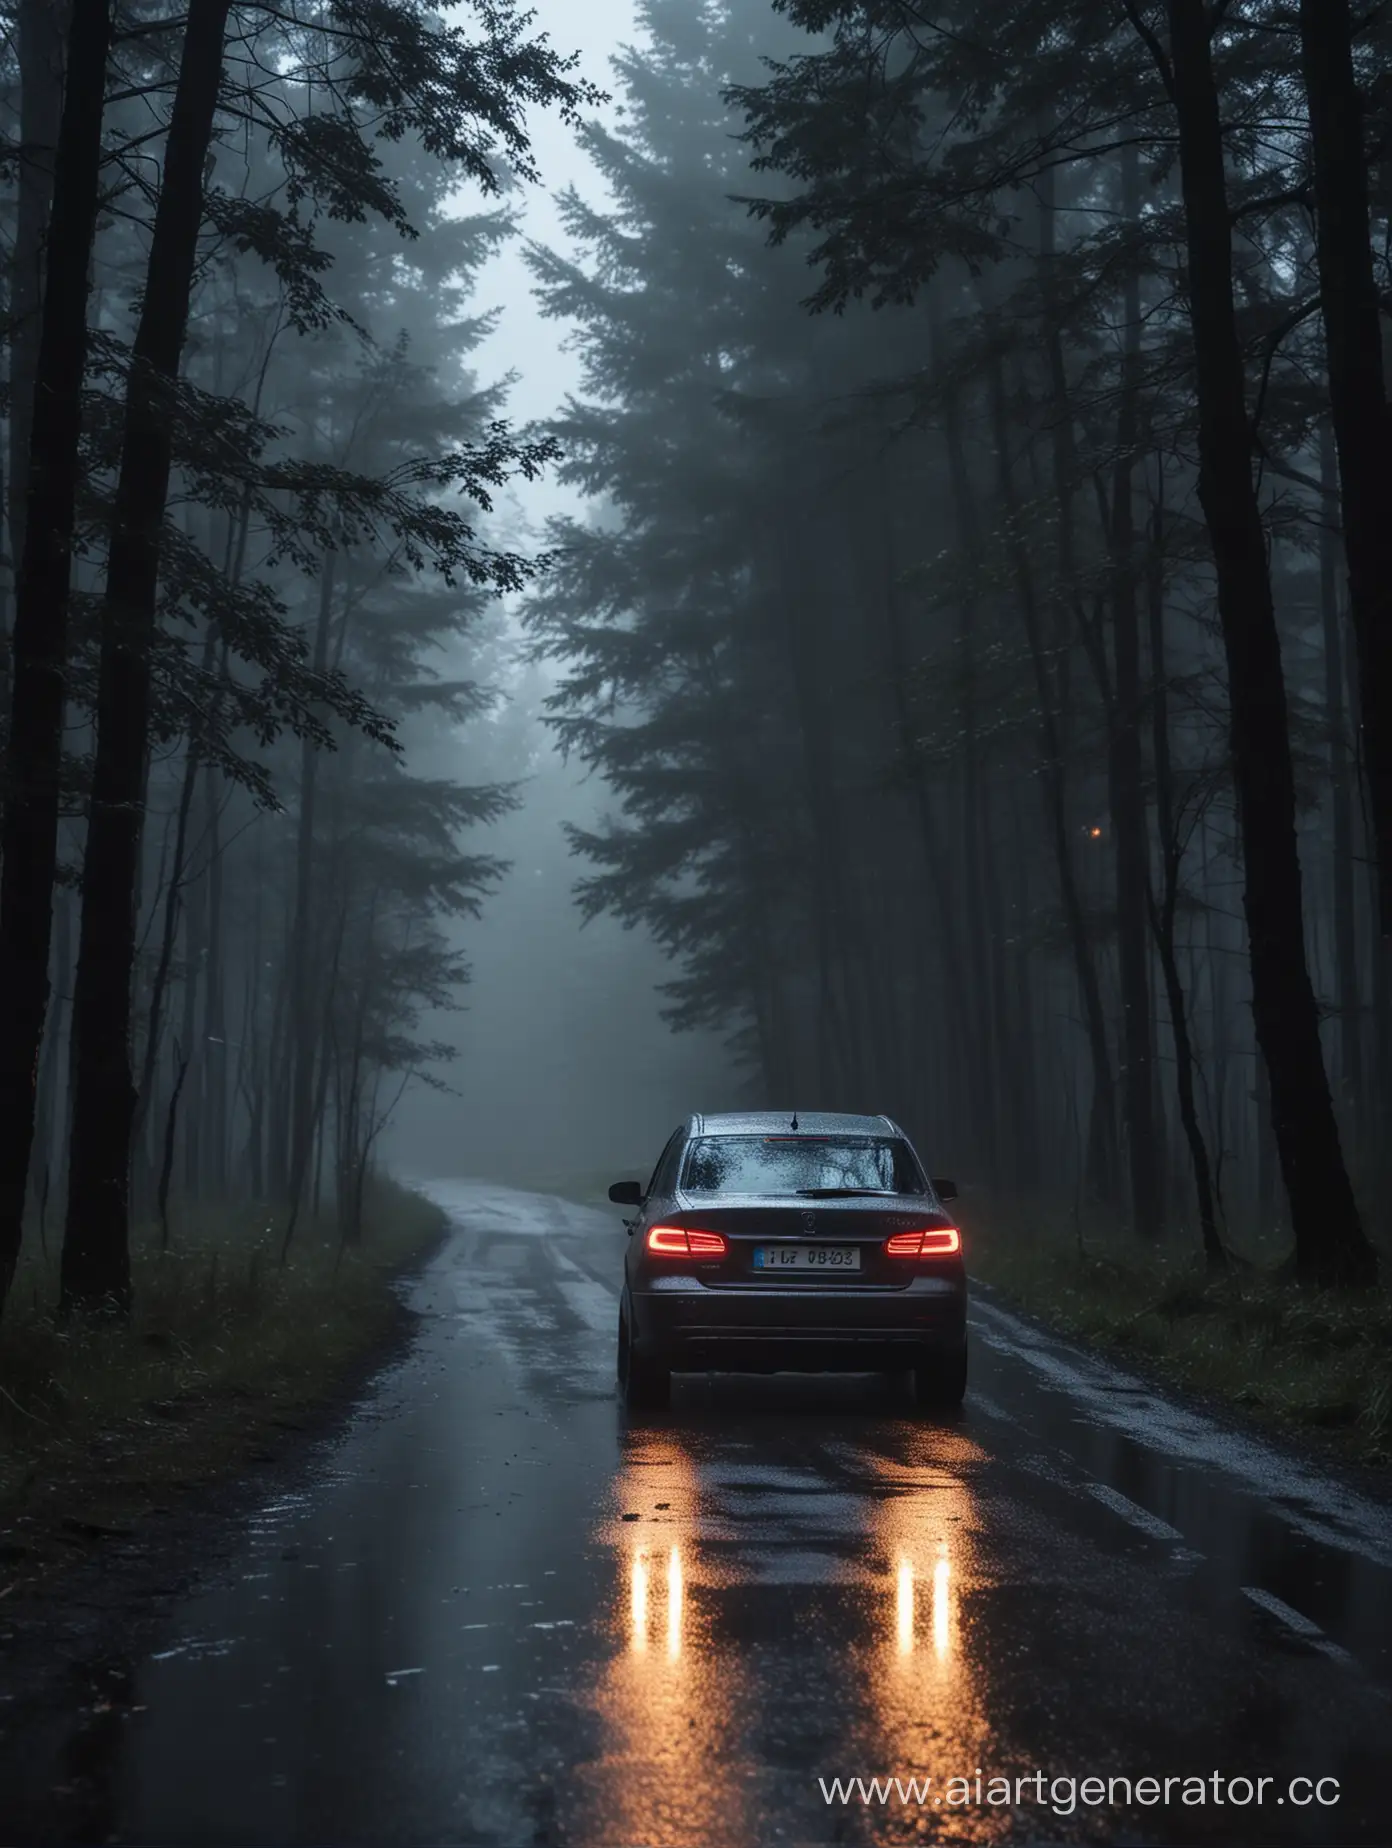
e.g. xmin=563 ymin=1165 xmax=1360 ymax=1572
xmin=608 ymin=1111 xmax=967 ymax=1408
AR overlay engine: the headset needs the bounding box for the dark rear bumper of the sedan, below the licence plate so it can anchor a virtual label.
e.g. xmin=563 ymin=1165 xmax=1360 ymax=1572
xmin=632 ymin=1277 xmax=967 ymax=1373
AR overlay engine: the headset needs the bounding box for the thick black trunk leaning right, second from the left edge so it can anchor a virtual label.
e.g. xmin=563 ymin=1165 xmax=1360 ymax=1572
xmin=59 ymin=0 xmax=229 ymax=1310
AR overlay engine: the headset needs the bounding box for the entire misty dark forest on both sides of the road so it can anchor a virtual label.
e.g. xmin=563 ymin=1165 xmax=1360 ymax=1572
xmin=0 ymin=0 xmax=1392 ymax=1337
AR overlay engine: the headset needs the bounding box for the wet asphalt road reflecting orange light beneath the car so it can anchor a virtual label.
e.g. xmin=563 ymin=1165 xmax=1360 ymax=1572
xmin=0 ymin=1183 xmax=1392 ymax=1848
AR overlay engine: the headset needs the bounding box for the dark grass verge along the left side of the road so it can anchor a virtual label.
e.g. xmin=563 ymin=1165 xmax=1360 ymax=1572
xmin=0 ymin=1177 xmax=446 ymax=1597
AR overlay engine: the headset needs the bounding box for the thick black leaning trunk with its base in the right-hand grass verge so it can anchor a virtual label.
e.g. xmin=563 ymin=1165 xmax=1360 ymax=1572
xmin=1168 ymin=0 xmax=1377 ymax=1284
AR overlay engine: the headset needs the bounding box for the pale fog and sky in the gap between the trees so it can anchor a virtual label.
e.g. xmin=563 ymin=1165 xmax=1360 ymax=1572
xmin=385 ymin=0 xmax=728 ymax=1185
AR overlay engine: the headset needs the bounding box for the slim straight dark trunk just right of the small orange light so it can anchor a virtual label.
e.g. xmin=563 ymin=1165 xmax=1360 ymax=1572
xmin=1107 ymin=148 xmax=1161 ymax=1240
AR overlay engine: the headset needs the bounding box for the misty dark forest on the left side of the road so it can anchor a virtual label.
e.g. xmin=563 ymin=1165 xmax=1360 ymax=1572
xmin=0 ymin=0 xmax=592 ymax=1310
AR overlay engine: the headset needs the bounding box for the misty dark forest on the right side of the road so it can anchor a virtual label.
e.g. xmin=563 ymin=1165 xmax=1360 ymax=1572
xmin=529 ymin=0 xmax=1392 ymax=1283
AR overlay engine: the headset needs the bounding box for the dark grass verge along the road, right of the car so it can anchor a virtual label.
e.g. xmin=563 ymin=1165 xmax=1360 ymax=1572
xmin=961 ymin=1198 xmax=1392 ymax=1464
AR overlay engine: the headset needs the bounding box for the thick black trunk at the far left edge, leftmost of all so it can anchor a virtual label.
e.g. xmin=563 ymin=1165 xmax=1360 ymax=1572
xmin=0 ymin=0 xmax=111 ymax=1312
